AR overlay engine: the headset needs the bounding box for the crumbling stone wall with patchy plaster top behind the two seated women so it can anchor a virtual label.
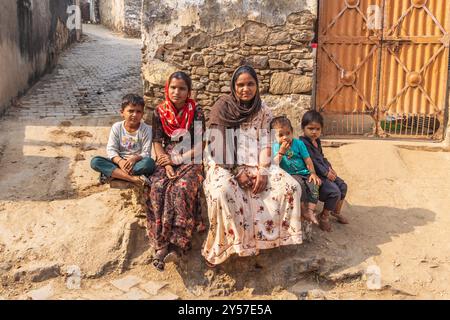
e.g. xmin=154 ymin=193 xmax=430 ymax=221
xmin=143 ymin=0 xmax=317 ymax=134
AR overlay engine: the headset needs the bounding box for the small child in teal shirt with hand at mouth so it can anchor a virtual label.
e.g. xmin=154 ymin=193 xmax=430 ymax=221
xmin=270 ymin=116 xmax=322 ymax=225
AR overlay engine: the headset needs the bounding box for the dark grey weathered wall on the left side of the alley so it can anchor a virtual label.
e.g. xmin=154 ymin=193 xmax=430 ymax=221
xmin=0 ymin=0 xmax=77 ymax=114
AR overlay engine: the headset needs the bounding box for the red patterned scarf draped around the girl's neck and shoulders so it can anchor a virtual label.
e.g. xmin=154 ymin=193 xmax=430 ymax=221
xmin=158 ymin=81 xmax=196 ymax=138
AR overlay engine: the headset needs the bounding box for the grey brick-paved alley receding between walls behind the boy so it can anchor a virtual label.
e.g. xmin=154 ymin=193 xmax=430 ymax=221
xmin=7 ymin=24 xmax=142 ymax=119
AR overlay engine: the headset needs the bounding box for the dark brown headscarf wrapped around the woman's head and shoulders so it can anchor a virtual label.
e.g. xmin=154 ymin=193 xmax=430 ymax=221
xmin=209 ymin=66 xmax=262 ymax=128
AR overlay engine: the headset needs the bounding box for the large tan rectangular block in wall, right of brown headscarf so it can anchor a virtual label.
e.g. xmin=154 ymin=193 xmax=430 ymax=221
xmin=270 ymin=72 xmax=312 ymax=94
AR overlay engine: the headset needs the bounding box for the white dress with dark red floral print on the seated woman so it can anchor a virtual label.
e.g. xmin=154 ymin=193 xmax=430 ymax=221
xmin=202 ymin=104 xmax=302 ymax=264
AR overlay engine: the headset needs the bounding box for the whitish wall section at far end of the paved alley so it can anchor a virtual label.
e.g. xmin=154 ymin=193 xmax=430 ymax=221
xmin=97 ymin=0 xmax=142 ymax=38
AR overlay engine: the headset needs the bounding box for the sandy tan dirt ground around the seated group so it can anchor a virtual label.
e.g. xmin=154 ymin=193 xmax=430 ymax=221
xmin=0 ymin=118 xmax=450 ymax=299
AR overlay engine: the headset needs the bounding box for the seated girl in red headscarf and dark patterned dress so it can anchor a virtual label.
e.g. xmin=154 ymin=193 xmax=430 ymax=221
xmin=147 ymin=71 xmax=205 ymax=271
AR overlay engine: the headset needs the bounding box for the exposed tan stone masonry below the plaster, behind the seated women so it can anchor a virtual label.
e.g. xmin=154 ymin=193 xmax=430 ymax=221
xmin=143 ymin=1 xmax=316 ymax=131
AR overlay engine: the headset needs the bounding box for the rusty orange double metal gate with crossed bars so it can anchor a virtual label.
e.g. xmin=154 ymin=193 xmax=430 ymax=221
xmin=316 ymin=0 xmax=450 ymax=139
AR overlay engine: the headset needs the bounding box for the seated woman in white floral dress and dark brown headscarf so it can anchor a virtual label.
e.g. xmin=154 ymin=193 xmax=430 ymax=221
xmin=202 ymin=66 xmax=302 ymax=266
